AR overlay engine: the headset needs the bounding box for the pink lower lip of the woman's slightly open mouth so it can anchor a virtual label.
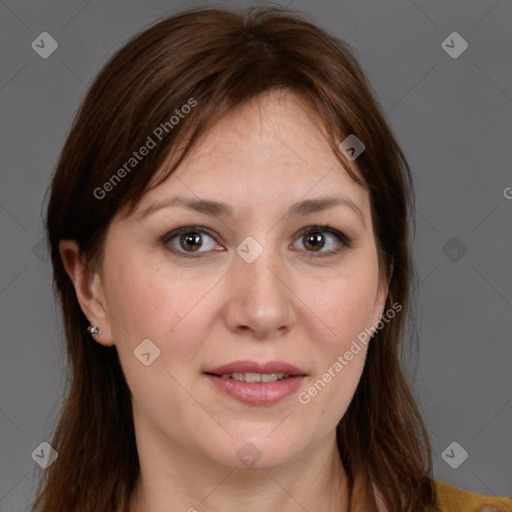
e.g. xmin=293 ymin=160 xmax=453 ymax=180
xmin=205 ymin=374 xmax=306 ymax=405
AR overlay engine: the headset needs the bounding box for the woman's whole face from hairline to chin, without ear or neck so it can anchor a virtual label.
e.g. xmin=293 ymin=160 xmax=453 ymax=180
xmin=96 ymin=92 xmax=387 ymax=468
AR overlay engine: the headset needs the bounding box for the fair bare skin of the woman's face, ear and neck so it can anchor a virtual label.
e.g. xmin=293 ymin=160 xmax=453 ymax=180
xmin=60 ymin=91 xmax=387 ymax=512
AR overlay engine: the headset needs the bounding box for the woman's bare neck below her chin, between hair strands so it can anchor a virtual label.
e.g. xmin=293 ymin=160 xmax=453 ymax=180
xmin=130 ymin=433 xmax=350 ymax=512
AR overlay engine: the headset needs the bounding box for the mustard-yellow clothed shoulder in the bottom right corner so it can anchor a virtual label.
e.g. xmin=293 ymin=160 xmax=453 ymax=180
xmin=434 ymin=481 xmax=512 ymax=512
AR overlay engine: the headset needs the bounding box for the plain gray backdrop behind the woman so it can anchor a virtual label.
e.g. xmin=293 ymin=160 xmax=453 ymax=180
xmin=0 ymin=0 xmax=512 ymax=512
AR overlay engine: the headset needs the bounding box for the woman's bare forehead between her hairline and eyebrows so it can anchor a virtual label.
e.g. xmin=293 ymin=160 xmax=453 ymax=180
xmin=138 ymin=91 xmax=369 ymax=216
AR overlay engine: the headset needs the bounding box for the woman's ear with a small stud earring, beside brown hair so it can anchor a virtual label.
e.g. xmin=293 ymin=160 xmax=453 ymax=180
xmin=59 ymin=240 xmax=114 ymax=346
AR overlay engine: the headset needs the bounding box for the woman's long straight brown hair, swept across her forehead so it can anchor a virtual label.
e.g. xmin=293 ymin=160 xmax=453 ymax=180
xmin=32 ymin=6 xmax=435 ymax=512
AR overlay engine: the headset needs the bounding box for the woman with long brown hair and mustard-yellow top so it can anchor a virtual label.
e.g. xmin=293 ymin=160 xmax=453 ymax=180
xmin=34 ymin=8 xmax=512 ymax=512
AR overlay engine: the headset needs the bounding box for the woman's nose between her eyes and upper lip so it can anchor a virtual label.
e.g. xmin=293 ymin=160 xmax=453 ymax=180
xmin=224 ymin=245 xmax=296 ymax=339
